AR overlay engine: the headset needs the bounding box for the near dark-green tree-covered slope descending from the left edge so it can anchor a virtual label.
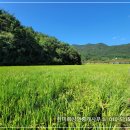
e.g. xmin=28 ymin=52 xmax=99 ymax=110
xmin=0 ymin=10 xmax=81 ymax=65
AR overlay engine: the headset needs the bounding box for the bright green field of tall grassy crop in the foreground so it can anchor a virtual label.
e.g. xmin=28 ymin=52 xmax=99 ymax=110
xmin=0 ymin=64 xmax=130 ymax=130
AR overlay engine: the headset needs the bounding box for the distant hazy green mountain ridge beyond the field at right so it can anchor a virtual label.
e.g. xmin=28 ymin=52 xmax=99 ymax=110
xmin=73 ymin=43 xmax=130 ymax=61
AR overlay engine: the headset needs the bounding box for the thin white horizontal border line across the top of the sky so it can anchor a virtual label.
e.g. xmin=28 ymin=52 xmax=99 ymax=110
xmin=0 ymin=1 xmax=130 ymax=4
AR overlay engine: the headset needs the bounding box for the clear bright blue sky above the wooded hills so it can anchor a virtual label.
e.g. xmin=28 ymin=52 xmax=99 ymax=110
xmin=0 ymin=0 xmax=130 ymax=45
